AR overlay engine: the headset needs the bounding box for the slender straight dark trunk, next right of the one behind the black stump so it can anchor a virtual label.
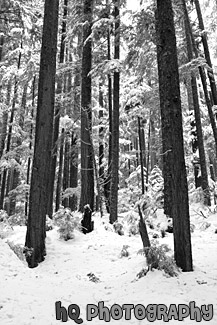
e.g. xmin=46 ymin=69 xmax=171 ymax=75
xmin=109 ymin=0 xmax=120 ymax=223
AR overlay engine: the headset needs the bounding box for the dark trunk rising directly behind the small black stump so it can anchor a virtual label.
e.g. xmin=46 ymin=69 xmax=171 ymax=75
xmin=79 ymin=0 xmax=94 ymax=212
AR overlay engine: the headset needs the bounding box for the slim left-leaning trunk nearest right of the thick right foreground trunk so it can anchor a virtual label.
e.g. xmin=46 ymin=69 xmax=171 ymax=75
xmin=183 ymin=0 xmax=211 ymax=205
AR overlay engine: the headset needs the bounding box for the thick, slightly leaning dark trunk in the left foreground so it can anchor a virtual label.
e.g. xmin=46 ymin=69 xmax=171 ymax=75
xmin=25 ymin=0 xmax=59 ymax=268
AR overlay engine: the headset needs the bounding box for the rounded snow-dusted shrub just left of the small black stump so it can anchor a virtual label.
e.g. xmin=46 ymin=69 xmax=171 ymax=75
xmin=54 ymin=208 xmax=81 ymax=240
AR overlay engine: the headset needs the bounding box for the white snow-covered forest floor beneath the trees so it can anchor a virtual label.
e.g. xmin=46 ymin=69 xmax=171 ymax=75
xmin=0 ymin=207 xmax=217 ymax=325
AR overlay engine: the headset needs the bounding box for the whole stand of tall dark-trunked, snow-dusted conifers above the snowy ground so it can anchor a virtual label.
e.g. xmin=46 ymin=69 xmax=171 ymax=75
xmin=0 ymin=0 xmax=217 ymax=271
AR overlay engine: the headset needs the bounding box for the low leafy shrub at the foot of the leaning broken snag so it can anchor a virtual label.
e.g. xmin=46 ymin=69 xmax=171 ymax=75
xmin=138 ymin=240 xmax=179 ymax=276
